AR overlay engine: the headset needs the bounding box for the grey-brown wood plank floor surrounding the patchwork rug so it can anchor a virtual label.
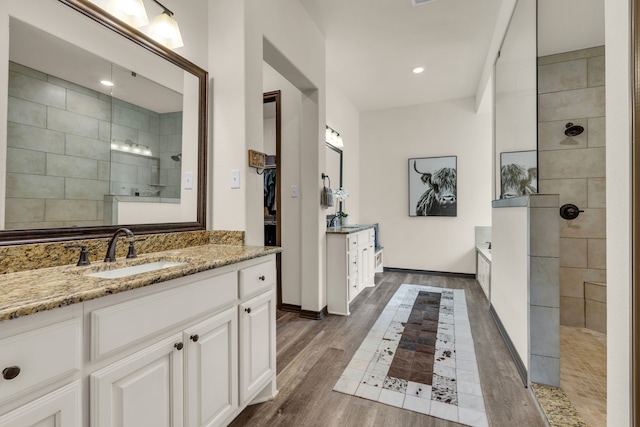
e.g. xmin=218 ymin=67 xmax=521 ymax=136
xmin=231 ymin=272 xmax=545 ymax=427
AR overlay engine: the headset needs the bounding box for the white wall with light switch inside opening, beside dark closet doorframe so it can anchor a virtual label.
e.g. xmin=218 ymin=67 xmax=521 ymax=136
xmin=263 ymin=63 xmax=302 ymax=306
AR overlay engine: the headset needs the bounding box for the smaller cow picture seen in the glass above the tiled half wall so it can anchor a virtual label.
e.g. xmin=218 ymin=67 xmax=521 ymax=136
xmin=500 ymin=150 xmax=538 ymax=199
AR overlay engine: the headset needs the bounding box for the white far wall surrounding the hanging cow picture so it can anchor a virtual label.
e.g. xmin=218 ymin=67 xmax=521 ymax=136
xmin=360 ymin=98 xmax=492 ymax=274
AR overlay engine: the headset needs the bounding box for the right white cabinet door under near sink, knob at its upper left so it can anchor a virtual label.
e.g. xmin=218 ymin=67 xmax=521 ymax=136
xmin=184 ymin=307 xmax=238 ymax=427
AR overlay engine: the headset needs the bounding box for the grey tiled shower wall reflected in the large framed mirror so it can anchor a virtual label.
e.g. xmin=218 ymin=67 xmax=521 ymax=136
xmin=5 ymin=63 xmax=182 ymax=229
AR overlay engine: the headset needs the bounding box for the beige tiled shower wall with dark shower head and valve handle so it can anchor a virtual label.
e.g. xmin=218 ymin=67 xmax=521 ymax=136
xmin=538 ymin=47 xmax=606 ymax=332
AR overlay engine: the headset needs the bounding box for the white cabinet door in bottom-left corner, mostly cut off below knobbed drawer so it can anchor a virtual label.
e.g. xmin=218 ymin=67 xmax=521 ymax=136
xmin=0 ymin=381 xmax=82 ymax=427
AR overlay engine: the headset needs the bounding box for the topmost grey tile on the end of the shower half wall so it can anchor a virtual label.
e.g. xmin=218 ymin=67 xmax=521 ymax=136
xmin=529 ymin=208 xmax=560 ymax=257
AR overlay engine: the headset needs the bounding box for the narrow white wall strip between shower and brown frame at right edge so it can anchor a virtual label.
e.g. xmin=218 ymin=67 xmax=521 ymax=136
xmin=605 ymin=0 xmax=638 ymax=426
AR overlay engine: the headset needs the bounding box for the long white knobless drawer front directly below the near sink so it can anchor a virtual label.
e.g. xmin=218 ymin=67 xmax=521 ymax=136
xmin=91 ymin=271 xmax=237 ymax=360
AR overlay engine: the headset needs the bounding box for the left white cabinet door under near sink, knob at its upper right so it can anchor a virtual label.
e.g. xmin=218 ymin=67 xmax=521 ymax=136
xmin=89 ymin=334 xmax=184 ymax=427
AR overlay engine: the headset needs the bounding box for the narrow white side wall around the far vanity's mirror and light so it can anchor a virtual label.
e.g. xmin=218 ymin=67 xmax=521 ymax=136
xmin=326 ymin=82 xmax=362 ymax=224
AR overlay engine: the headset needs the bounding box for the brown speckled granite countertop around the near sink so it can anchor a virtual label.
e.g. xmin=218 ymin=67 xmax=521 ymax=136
xmin=0 ymin=245 xmax=282 ymax=321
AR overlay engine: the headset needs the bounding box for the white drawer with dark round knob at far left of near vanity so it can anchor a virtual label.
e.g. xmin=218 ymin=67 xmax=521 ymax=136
xmin=0 ymin=318 xmax=82 ymax=402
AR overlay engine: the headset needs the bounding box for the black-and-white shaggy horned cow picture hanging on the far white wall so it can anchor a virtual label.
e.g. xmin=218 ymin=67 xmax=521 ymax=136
xmin=409 ymin=157 xmax=458 ymax=216
